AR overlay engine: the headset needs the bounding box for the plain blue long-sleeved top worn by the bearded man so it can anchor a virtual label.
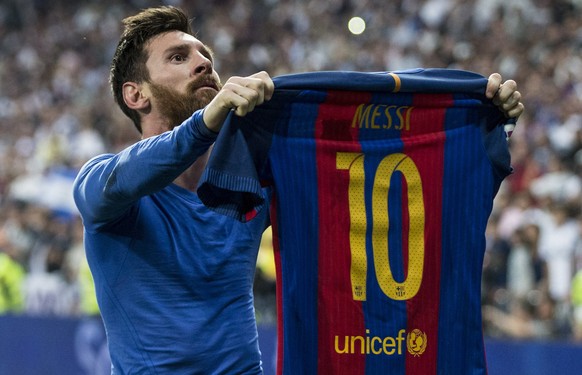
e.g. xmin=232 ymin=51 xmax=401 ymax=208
xmin=74 ymin=111 xmax=268 ymax=375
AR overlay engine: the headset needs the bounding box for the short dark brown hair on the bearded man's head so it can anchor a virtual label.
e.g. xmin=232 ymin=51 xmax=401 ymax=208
xmin=109 ymin=6 xmax=192 ymax=133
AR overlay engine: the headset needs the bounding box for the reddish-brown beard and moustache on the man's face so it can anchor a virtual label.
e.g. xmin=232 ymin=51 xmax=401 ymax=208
xmin=150 ymin=78 xmax=222 ymax=129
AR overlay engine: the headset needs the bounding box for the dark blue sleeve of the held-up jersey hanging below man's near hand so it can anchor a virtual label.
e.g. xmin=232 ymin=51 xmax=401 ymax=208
xmin=197 ymin=95 xmax=295 ymax=222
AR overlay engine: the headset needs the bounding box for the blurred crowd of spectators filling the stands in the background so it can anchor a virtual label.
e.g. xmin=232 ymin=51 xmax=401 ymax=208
xmin=0 ymin=0 xmax=582 ymax=340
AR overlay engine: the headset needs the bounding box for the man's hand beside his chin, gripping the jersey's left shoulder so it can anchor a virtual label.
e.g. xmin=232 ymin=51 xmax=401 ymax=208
xmin=203 ymin=72 xmax=275 ymax=132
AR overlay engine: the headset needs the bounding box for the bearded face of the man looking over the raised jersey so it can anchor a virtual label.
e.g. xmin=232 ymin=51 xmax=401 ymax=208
xmin=146 ymin=31 xmax=221 ymax=128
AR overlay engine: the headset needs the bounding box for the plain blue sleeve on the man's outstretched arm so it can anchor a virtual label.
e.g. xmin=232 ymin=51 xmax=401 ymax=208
xmin=73 ymin=110 xmax=217 ymax=227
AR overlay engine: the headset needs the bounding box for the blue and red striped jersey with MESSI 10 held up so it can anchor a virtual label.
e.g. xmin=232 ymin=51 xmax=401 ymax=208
xmin=198 ymin=69 xmax=511 ymax=375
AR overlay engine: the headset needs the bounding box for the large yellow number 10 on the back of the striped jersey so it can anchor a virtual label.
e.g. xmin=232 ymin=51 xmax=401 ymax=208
xmin=336 ymin=152 xmax=425 ymax=301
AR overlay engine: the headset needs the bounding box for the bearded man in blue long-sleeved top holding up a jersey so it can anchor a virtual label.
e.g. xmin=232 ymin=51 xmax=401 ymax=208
xmin=74 ymin=7 xmax=521 ymax=375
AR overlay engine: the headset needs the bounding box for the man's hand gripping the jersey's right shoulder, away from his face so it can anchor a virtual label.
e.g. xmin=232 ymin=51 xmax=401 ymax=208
xmin=485 ymin=73 xmax=524 ymax=119
